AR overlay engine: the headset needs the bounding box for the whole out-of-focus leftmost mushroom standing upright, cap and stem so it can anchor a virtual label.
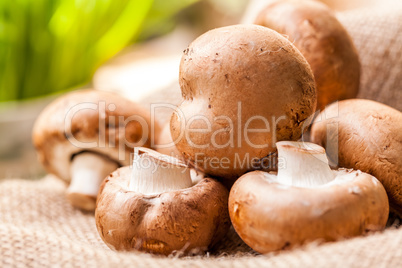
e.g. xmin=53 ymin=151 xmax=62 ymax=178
xmin=33 ymin=90 xmax=159 ymax=210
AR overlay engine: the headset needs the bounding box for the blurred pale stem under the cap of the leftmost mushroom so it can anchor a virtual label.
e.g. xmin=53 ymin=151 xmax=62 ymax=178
xmin=67 ymin=152 xmax=119 ymax=211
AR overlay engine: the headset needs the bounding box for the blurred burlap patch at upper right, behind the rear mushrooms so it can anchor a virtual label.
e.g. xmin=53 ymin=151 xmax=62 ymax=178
xmin=338 ymin=1 xmax=402 ymax=111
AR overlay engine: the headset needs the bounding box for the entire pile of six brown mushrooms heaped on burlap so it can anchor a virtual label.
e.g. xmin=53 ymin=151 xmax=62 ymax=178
xmin=33 ymin=0 xmax=402 ymax=255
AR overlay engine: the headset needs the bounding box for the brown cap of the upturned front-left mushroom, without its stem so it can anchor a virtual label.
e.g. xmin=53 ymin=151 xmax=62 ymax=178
xmin=95 ymin=167 xmax=230 ymax=255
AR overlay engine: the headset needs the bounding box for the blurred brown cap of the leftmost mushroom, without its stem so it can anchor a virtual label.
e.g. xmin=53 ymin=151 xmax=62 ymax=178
xmin=32 ymin=90 xmax=159 ymax=181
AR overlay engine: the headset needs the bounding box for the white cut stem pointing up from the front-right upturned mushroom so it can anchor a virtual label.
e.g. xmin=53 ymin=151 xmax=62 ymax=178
xmin=276 ymin=141 xmax=335 ymax=188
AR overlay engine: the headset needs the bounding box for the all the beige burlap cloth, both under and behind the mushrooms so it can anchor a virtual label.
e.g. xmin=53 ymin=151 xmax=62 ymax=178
xmin=0 ymin=2 xmax=402 ymax=267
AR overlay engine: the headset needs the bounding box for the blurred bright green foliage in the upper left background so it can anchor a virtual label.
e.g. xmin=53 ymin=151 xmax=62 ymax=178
xmin=0 ymin=0 xmax=197 ymax=102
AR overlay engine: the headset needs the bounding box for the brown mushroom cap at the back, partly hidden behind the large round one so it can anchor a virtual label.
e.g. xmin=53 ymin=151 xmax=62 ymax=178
xmin=255 ymin=0 xmax=360 ymax=110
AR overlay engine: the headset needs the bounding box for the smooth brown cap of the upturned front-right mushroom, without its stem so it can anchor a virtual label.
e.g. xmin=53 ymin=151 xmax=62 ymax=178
xmin=229 ymin=170 xmax=388 ymax=253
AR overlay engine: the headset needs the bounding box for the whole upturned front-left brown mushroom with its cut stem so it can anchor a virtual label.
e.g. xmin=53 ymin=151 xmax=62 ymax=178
xmin=95 ymin=148 xmax=230 ymax=255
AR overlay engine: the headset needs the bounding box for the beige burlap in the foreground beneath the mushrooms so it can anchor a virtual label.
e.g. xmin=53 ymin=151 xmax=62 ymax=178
xmin=0 ymin=176 xmax=402 ymax=268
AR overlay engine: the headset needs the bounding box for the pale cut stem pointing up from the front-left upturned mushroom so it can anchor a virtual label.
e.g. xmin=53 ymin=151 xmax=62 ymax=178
xmin=129 ymin=148 xmax=193 ymax=194
